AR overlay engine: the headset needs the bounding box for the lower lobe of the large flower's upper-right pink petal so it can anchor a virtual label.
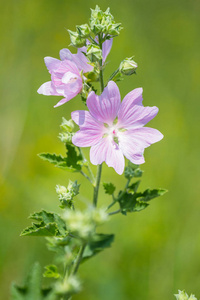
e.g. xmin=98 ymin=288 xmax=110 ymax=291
xmin=118 ymin=105 xmax=158 ymax=129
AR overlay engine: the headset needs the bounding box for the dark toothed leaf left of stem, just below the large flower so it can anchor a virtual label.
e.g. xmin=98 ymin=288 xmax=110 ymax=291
xmin=38 ymin=144 xmax=84 ymax=172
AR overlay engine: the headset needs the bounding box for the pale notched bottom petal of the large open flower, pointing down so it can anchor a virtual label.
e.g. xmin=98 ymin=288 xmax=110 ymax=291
xmin=90 ymin=137 xmax=125 ymax=175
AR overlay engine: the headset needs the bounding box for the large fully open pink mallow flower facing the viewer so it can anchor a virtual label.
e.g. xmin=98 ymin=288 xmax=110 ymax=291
xmin=71 ymin=81 xmax=163 ymax=175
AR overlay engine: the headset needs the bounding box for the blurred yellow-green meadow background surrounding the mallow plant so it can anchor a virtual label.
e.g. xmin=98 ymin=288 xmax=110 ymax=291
xmin=0 ymin=0 xmax=200 ymax=300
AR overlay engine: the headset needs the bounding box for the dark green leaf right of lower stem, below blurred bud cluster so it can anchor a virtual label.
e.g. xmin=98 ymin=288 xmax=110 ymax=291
xmin=82 ymin=234 xmax=114 ymax=262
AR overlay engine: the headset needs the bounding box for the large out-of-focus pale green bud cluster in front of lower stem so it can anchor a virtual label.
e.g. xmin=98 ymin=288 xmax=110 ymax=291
xmin=63 ymin=208 xmax=108 ymax=240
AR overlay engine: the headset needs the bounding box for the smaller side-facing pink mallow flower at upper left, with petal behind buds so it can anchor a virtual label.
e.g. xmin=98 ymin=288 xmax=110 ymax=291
xmin=37 ymin=40 xmax=112 ymax=107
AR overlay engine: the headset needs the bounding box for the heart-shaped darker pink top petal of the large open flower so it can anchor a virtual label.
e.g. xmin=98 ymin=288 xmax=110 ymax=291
xmin=86 ymin=81 xmax=121 ymax=125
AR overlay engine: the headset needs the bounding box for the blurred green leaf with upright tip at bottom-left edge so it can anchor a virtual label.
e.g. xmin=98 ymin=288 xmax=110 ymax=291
xmin=11 ymin=263 xmax=56 ymax=300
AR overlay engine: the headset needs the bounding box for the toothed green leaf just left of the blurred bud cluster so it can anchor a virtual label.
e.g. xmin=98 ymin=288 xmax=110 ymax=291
xmin=21 ymin=210 xmax=67 ymax=237
